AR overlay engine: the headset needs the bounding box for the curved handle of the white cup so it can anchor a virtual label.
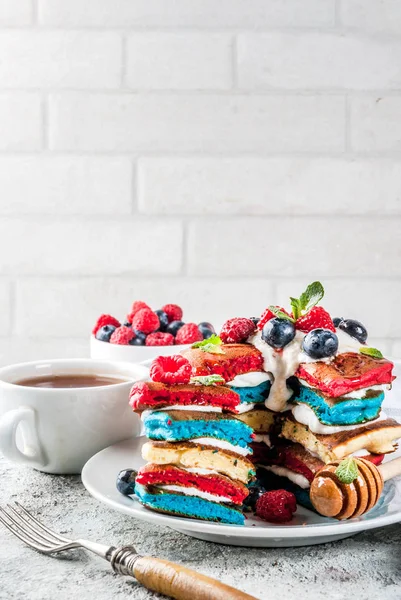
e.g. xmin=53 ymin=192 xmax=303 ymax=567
xmin=0 ymin=406 xmax=47 ymax=469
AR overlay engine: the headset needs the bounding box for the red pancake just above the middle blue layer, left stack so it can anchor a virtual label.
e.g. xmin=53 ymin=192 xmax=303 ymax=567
xmin=130 ymin=381 xmax=240 ymax=412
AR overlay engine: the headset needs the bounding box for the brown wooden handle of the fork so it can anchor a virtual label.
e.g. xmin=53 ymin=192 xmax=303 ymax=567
xmin=133 ymin=556 xmax=257 ymax=600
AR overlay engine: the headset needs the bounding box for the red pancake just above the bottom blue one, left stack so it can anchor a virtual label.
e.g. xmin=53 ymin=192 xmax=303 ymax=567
xmin=135 ymin=463 xmax=249 ymax=504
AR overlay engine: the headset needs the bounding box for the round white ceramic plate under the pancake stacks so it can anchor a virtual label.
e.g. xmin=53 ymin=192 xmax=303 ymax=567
xmin=82 ymin=437 xmax=401 ymax=547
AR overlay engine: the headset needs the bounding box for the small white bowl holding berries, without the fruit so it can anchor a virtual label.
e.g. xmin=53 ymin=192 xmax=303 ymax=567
xmin=90 ymin=335 xmax=191 ymax=363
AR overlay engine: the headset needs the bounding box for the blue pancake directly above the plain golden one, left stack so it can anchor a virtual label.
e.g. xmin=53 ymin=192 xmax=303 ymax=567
xmin=143 ymin=407 xmax=253 ymax=452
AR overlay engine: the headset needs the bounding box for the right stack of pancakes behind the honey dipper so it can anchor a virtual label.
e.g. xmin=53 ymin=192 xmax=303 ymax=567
xmin=259 ymin=352 xmax=401 ymax=506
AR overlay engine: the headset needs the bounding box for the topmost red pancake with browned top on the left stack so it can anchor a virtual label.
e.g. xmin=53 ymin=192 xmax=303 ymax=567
xmin=182 ymin=344 xmax=263 ymax=381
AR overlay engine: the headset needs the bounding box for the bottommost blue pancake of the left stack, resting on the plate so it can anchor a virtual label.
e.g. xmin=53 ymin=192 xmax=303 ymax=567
xmin=135 ymin=483 xmax=245 ymax=525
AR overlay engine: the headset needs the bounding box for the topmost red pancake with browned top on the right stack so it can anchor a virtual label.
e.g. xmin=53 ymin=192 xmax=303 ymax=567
xmin=296 ymin=352 xmax=395 ymax=398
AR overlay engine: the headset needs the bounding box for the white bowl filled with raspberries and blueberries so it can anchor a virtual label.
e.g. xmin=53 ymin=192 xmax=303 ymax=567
xmin=90 ymin=300 xmax=215 ymax=362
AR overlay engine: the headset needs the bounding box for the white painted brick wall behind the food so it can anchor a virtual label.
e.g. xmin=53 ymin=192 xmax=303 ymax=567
xmin=0 ymin=0 xmax=401 ymax=364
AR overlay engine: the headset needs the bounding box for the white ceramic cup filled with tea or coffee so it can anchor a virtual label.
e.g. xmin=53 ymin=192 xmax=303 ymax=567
xmin=0 ymin=358 xmax=148 ymax=474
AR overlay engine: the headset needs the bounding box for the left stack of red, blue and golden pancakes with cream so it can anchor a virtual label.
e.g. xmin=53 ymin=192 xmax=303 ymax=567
xmin=131 ymin=344 xmax=273 ymax=524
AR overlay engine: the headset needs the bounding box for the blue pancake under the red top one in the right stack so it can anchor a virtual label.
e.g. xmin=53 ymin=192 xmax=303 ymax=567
xmin=292 ymin=385 xmax=384 ymax=425
